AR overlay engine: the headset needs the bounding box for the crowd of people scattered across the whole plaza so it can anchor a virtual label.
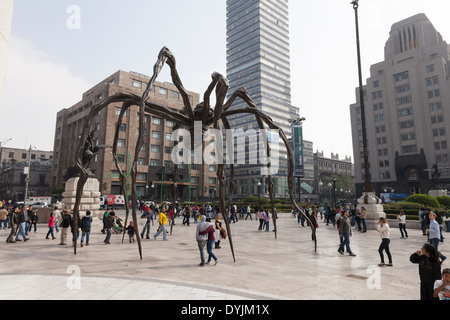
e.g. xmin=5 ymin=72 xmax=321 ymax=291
xmin=0 ymin=203 xmax=450 ymax=300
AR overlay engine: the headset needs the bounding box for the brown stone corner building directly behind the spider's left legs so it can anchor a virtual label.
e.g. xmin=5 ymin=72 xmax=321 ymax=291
xmin=51 ymin=71 xmax=220 ymax=201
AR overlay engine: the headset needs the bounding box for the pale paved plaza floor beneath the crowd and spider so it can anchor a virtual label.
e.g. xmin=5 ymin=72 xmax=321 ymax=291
xmin=0 ymin=211 xmax=450 ymax=301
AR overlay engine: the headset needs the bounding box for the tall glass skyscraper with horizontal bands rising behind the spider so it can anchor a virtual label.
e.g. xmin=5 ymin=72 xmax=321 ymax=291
xmin=227 ymin=0 xmax=299 ymax=198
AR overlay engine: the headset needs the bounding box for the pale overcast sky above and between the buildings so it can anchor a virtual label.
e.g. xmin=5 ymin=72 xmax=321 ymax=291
xmin=0 ymin=0 xmax=450 ymax=158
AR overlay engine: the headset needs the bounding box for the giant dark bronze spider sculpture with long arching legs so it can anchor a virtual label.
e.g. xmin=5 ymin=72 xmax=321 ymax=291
xmin=73 ymin=47 xmax=317 ymax=261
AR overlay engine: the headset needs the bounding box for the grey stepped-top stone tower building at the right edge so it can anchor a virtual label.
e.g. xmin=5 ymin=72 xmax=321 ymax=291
xmin=350 ymin=14 xmax=450 ymax=194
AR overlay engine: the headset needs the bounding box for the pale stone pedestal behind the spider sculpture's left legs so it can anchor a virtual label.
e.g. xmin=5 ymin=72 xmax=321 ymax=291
xmin=62 ymin=178 xmax=102 ymax=219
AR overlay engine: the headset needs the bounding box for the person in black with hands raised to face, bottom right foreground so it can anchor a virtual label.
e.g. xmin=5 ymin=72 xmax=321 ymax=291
xmin=409 ymin=243 xmax=442 ymax=300
